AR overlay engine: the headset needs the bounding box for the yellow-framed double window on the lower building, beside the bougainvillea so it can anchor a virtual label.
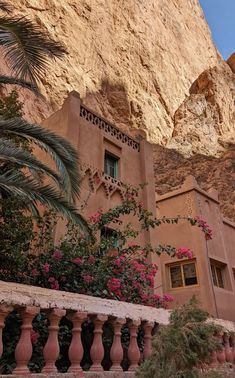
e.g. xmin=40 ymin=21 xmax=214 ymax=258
xmin=169 ymin=262 xmax=198 ymax=288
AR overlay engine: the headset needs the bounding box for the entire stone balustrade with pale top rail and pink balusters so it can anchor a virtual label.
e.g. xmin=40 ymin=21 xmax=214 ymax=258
xmin=0 ymin=282 xmax=235 ymax=377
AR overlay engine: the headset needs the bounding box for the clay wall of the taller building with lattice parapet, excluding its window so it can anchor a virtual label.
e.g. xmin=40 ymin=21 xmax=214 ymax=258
xmin=40 ymin=92 xmax=156 ymax=262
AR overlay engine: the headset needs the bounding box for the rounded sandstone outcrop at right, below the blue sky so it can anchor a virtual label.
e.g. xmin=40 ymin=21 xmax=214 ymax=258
xmin=167 ymin=62 xmax=235 ymax=156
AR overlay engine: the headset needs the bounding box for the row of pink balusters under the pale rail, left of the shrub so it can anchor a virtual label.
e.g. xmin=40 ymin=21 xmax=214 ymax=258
xmin=0 ymin=306 xmax=157 ymax=377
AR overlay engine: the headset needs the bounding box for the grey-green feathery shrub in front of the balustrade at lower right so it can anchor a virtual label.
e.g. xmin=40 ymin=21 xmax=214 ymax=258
xmin=137 ymin=298 xmax=221 ymax=378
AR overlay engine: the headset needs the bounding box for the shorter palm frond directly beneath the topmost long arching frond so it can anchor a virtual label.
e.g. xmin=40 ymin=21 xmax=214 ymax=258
xmin=0 ymin=138 xmax=63 ymax=190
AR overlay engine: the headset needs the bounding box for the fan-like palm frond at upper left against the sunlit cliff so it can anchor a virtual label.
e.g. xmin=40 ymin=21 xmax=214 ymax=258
xmin=0 ymin=16 xmax=66 ymax=83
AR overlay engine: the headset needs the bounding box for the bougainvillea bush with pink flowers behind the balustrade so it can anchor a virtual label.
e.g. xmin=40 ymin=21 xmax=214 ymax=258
xmin=0 ymin=188 xmax=211 ymax=307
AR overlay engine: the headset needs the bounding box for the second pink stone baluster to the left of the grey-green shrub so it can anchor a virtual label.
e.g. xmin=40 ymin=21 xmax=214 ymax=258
xmin=127 ymin=320 xmax=140 ymax=371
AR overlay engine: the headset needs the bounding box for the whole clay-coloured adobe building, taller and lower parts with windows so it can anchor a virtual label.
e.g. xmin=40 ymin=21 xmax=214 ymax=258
xmin=43 ymin=91 xmax=235 ymax=321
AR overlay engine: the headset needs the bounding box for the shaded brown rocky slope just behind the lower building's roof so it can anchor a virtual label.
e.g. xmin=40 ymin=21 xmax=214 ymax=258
xmin=154 ymin=144 xmax=235 ymax=221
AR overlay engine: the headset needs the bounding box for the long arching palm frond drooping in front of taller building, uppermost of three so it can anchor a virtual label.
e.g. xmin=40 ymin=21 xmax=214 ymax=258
xmin=0 ymin=118 xmax=80 ymax=199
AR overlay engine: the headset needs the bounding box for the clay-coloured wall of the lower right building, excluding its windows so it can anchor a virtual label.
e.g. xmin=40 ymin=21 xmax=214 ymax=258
xmin=156 ymin=177 xmax=235 ymax=320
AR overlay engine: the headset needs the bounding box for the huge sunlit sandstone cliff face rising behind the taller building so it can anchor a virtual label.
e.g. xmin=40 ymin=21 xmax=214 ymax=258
xmin=5 ymin=0 xmax=221 ymax=144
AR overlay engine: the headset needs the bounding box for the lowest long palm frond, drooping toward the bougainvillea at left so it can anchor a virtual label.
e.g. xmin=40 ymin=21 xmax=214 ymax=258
xmin=0 ymin=172 xmax=88 ymax=231
